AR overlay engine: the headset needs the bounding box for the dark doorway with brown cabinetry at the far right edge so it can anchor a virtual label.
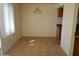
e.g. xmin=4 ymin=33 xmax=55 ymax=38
xmin=73 ymin=8 xmax=79 ymax=56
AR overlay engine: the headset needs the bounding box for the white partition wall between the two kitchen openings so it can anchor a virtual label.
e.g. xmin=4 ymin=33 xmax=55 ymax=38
xmin=61 ymin=4 xmax=78 ymax=55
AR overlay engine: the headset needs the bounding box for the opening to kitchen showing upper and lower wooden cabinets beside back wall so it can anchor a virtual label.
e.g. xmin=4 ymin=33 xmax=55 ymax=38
xmin=56 ymin=6 xmax=64 ymax=44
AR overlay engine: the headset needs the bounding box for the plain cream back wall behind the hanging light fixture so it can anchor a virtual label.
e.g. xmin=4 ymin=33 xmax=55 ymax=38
xmin=21 ymin=4 xmax=57 ymax=37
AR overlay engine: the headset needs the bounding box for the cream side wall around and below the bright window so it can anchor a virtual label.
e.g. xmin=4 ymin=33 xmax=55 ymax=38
xmin=0 ymin=4 xmax=21 ymax=53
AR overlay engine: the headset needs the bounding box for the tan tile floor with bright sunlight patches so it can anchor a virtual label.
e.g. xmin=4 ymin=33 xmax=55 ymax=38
xmin=6 ymin=37 xmax=66 ymax=56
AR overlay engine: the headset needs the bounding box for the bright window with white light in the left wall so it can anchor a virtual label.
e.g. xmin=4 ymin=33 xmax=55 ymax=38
xmin=3 ymin=4 xmax=15 ymax=36
